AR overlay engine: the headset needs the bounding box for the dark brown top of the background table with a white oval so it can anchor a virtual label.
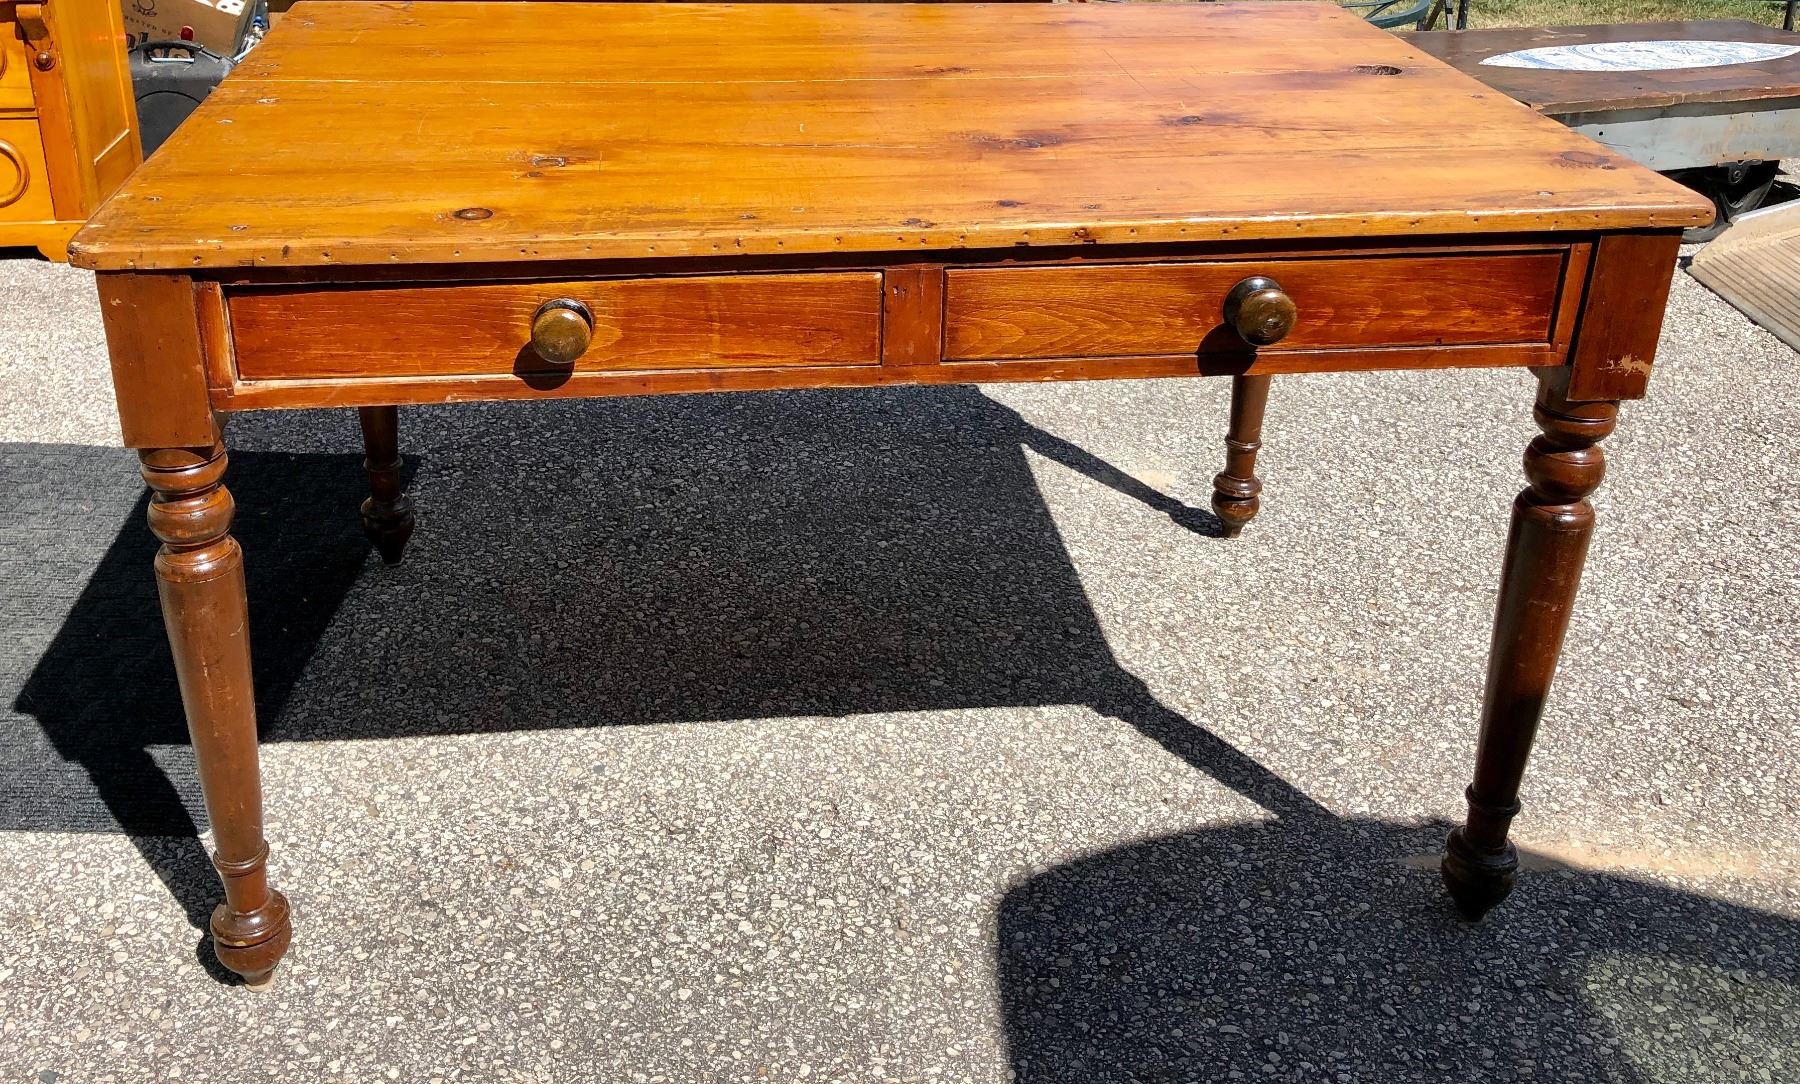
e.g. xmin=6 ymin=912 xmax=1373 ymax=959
xmin=1408 ymin=18 xmax=1800 ymax=115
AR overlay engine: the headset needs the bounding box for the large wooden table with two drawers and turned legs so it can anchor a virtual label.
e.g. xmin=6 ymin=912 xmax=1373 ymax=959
xmin=72 ymin=2 xmax=1710 ymax=983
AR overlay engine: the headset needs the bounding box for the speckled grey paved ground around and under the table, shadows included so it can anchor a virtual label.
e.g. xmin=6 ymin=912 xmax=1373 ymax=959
xmin=0 ymin=244 xmax=1800 ymax=1084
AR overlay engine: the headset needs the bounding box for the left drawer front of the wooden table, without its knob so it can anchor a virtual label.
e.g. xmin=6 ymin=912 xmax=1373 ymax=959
xmin=227 ymin=270 xmax=882 ymax=380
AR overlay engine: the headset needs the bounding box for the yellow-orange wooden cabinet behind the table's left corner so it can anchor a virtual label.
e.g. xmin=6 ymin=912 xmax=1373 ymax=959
xmin=0 ymin=0 xmax=142 ymax=259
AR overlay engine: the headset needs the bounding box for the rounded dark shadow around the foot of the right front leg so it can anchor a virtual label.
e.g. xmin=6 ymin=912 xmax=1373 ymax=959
xmin=995 ymin=818 xmax=1800 ymax=1084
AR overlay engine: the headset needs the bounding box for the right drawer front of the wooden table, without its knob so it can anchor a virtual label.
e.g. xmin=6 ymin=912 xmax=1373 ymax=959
xmin=943 ymin=248 xmax=1566 ymax=362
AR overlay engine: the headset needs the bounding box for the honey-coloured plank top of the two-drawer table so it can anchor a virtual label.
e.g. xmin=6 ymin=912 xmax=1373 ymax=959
xmin=70 ymin=0 xmax=1712 ymax=270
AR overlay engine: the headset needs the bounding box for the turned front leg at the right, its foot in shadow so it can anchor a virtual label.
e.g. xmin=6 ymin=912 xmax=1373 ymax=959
xmin=1442 ymin=369 xmax=1618 ymax=918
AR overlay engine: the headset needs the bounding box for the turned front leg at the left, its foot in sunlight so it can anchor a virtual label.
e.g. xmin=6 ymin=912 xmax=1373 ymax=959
xmin=139 ymin=433 xmax=292 ymax=987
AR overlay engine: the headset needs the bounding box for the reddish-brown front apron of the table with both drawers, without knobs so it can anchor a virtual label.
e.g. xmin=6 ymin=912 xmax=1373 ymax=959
xmin=200 ymin=241 xmax=1593 ymax=411
